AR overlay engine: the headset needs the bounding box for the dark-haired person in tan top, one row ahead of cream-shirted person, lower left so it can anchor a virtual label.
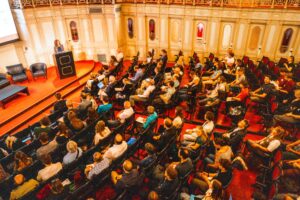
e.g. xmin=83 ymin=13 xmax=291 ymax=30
xmin=36 ymin=132 xmax=58 ymax=159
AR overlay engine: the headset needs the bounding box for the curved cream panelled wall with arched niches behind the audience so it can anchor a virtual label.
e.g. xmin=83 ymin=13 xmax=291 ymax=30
xmin=0 ymin=4 xmax=300 ymax=71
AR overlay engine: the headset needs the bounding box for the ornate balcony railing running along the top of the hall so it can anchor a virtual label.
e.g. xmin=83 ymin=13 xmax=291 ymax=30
xmin=10 ymin=0 xmax=300 ymax=9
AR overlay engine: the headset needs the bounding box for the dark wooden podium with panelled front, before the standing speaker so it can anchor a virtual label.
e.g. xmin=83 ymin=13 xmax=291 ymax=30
xmin=54 ymin=51 xmax=76 ymax=79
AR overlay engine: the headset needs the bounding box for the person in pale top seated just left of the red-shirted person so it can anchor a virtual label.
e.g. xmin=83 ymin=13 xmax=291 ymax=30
xmin=199 ymin=76 xmax=227 ymax=106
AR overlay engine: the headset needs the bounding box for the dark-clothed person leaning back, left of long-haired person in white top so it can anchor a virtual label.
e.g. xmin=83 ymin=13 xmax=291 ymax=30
xmin=215 ymin=119 xmax=249 ymax=154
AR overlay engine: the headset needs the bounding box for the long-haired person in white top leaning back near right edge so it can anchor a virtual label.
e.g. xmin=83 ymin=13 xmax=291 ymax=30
xmin=247 ymin=126 xmax=285 ymax=157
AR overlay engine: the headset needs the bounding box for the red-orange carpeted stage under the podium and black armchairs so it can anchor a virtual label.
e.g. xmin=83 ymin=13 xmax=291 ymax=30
xmin=0 ymin=61 xmax=95 ymax=135
